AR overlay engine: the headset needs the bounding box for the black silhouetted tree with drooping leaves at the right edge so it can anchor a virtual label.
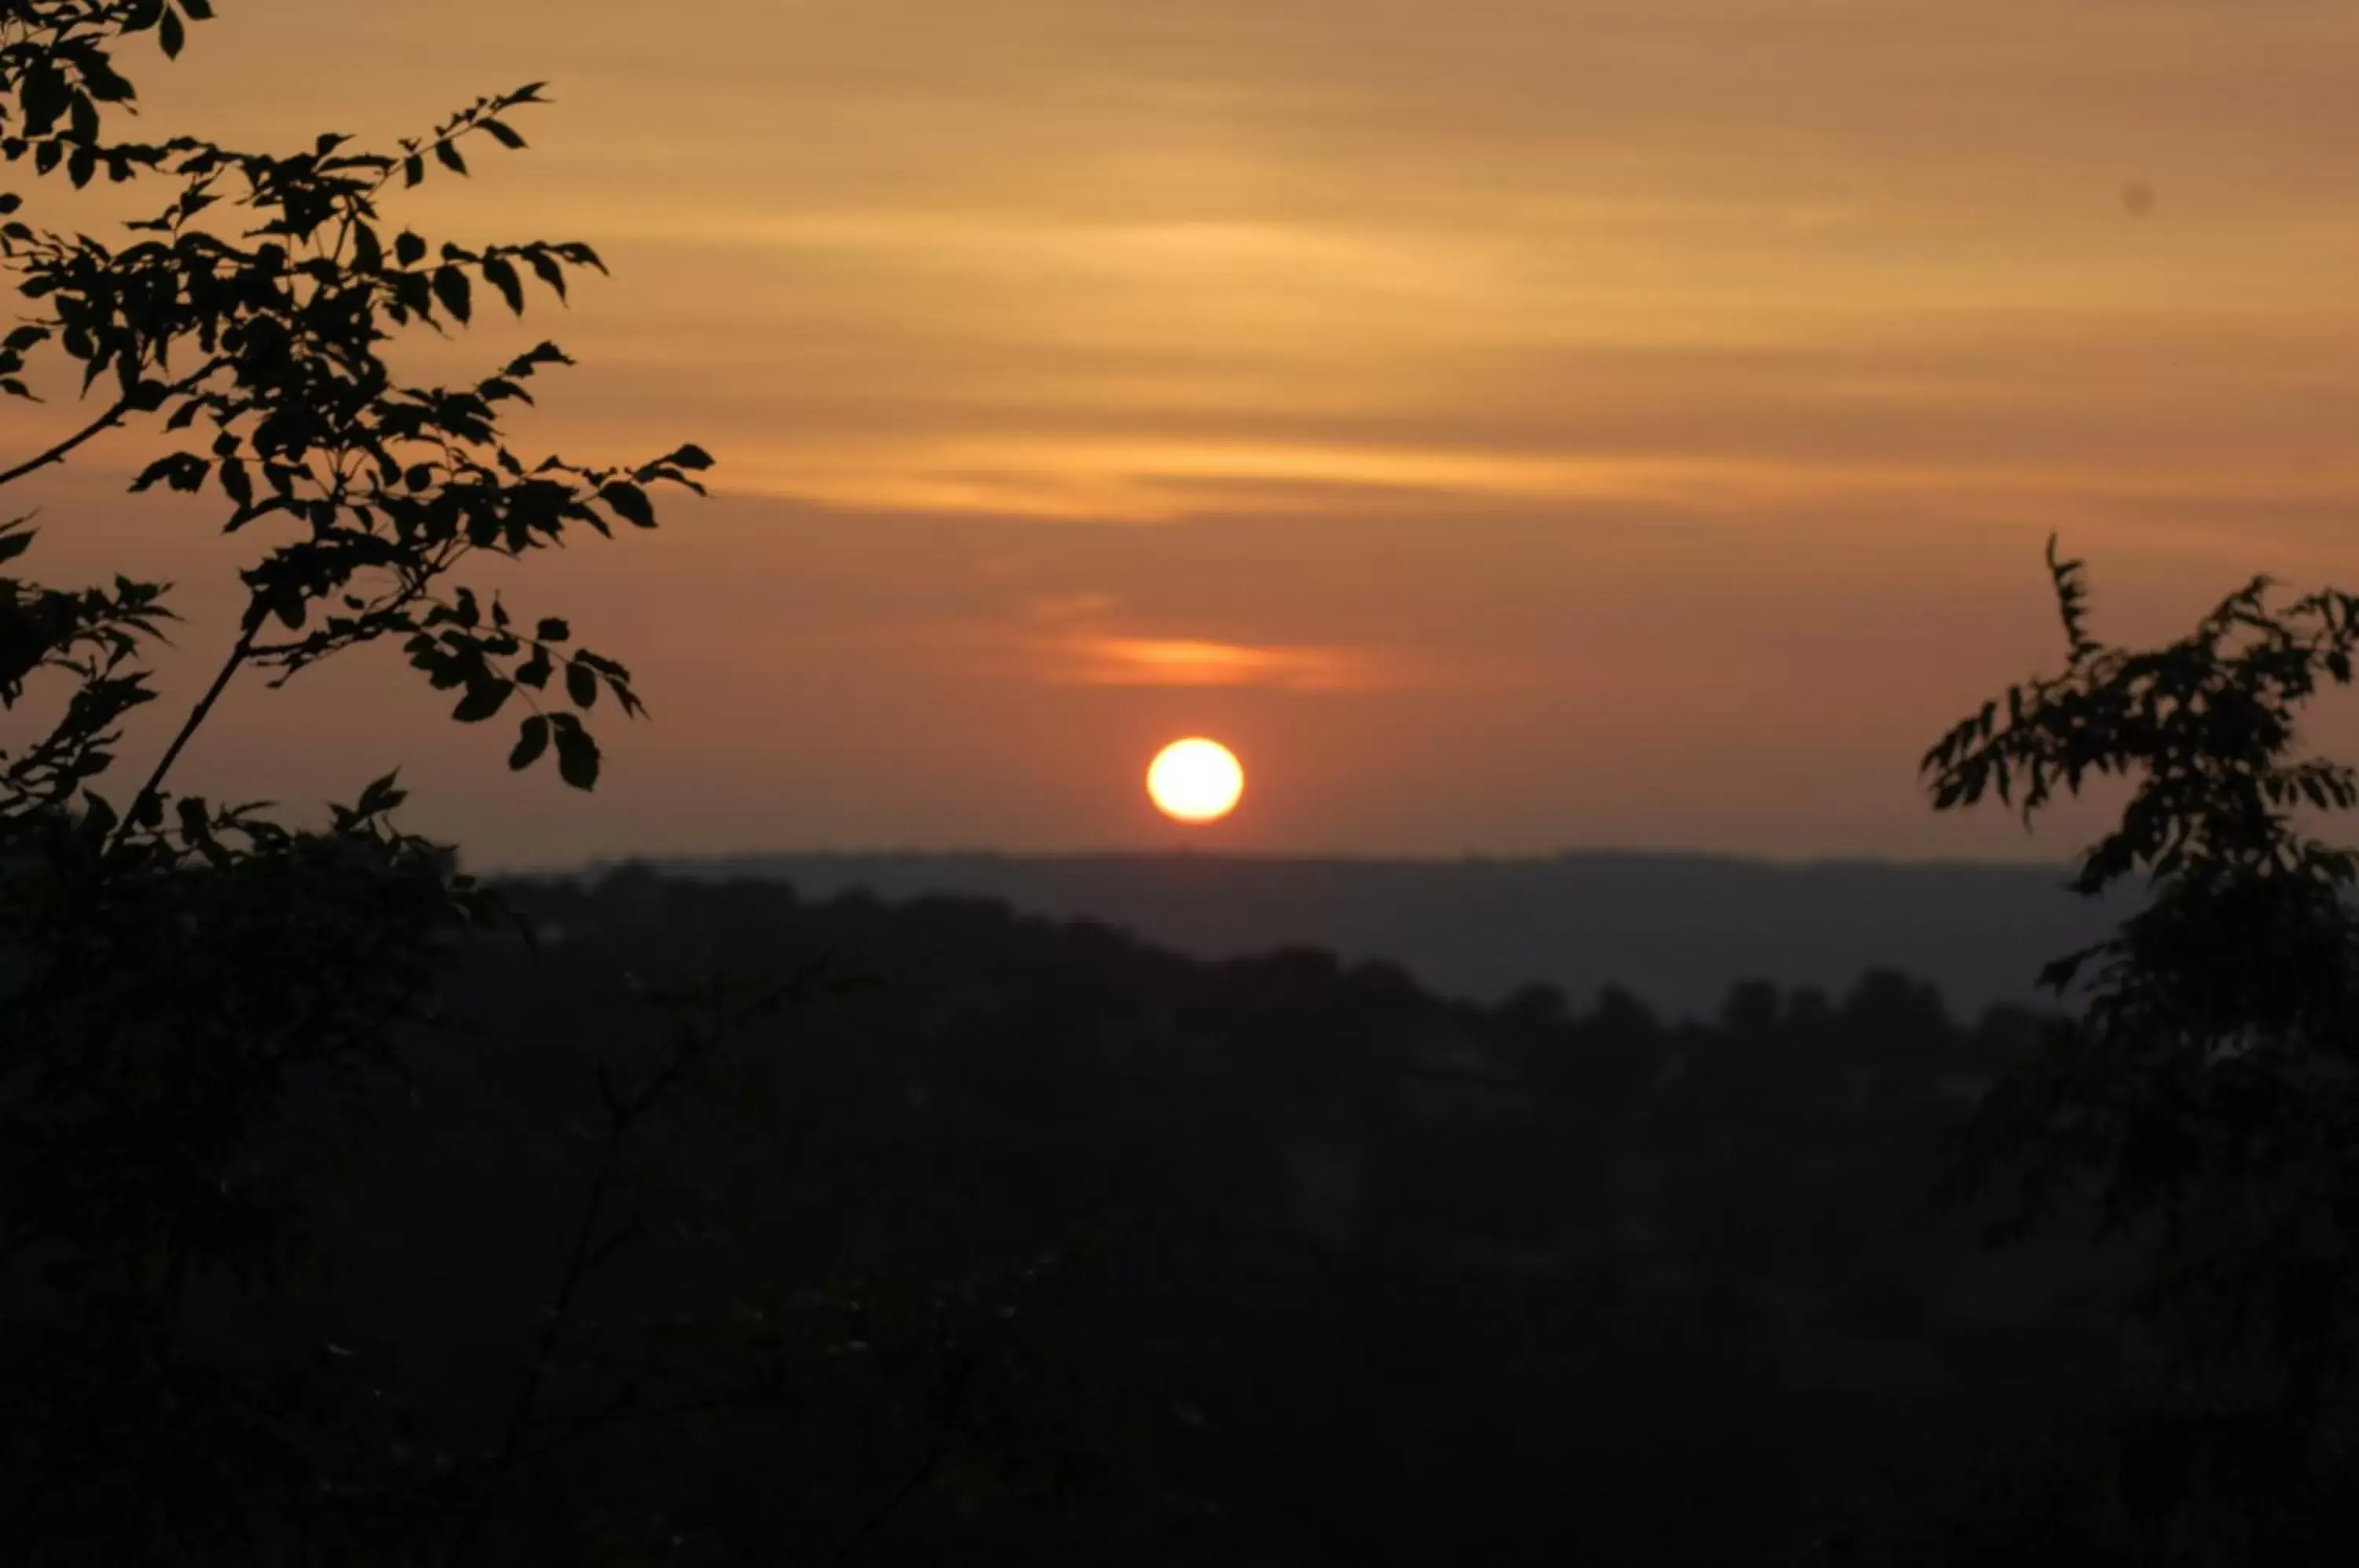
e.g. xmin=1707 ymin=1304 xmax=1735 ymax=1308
xmin=1925 ymin=543 xmax=2359 ymax=1561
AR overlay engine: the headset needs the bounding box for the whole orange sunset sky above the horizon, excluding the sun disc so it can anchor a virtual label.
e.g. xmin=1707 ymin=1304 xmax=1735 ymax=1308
xmin=13 ymin=0 xmax=2359 ymax=865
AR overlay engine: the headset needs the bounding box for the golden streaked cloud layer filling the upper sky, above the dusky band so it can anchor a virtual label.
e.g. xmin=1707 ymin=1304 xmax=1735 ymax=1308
xmin=184 ymin=0 xmax=2359 ymax=549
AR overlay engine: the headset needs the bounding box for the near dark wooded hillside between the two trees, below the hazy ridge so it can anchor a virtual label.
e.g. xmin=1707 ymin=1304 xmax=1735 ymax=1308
xmin=9 ymin=844 xmax=2359 ymax=1563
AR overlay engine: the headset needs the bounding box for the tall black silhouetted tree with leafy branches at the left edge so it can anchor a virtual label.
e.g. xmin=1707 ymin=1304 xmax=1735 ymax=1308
xmin=0 ymin=0 xmax=710 ymax=1561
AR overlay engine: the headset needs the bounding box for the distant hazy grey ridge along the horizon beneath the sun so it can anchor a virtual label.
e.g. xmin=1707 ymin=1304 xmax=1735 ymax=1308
xmin=663 ymin=853 xmax=2125 ymax=1018
